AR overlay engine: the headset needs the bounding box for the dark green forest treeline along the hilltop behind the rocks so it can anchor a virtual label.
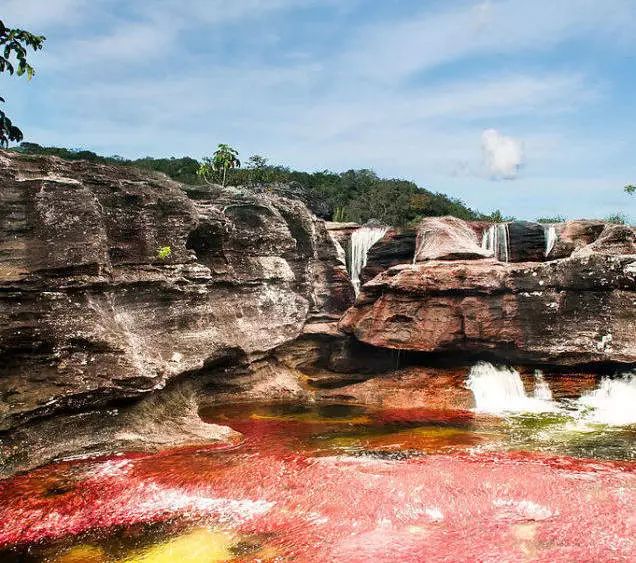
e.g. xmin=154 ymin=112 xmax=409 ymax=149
xmin=13 ymin=143 xmax=507 ymax=226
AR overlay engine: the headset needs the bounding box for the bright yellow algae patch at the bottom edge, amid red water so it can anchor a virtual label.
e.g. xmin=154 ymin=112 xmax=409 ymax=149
xmin=121 ymin=528 xmax=236 ymax=563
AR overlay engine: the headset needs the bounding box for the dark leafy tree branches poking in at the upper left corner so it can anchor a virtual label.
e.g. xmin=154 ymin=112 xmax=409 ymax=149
xmin=0 ymin=20 xmax=45 ymax=147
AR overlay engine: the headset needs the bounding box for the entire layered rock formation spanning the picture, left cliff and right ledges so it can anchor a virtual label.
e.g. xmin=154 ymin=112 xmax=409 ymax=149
xmin=0 ymin=151 xmax=636 ymax=473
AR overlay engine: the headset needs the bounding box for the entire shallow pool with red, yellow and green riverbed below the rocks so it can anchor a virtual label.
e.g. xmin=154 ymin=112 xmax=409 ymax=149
xmin=0 ymin=398 xmax=636 ymax=563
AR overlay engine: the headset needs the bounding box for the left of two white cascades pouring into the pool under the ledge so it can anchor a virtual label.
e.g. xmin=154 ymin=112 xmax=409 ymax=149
xmin=466 ymin=362 xmax=556 ymax=414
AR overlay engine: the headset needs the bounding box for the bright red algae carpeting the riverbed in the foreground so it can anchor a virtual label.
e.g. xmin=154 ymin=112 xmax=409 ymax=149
xmin=0 ymin=404 xmax=636 ymax=562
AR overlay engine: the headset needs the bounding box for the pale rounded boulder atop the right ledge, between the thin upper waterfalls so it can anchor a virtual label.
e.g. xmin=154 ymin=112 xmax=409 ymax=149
xmin=415 ymin=216 xmax=492 ymax=262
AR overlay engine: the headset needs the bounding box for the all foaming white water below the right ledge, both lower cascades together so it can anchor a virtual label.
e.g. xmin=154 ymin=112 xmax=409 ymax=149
xmin=466 ymin=362 xmax=636 ymax=431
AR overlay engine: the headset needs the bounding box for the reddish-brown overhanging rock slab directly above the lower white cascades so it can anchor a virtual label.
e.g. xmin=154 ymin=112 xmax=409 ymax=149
xmin=340 ymin=254 xmax=636 ymax=365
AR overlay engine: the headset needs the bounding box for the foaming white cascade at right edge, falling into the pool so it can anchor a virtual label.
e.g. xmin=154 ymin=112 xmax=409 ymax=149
xmin=577 ymin=374 xmax=636 ymax=426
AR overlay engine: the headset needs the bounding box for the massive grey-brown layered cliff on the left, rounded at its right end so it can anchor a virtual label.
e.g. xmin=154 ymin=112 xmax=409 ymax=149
xmin=0 ymin=151 xmax=353 ymax=430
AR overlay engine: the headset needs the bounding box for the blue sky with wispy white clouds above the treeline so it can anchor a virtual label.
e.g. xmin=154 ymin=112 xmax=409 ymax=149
xmin=0 ymin=0 xmax=636 ymax=220
